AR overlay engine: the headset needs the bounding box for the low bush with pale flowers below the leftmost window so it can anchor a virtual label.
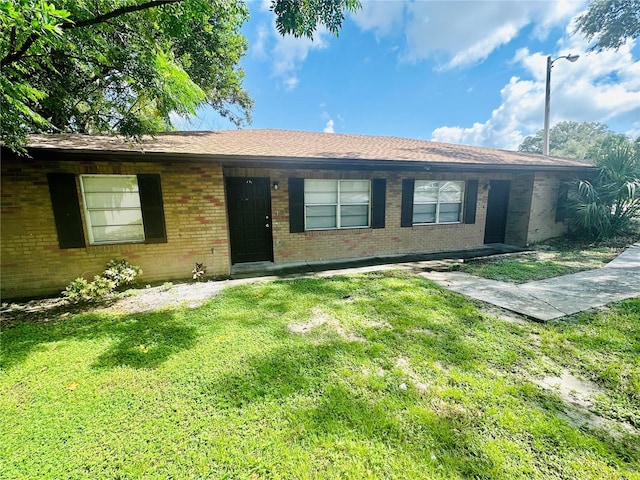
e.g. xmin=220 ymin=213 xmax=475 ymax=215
xmin=62 ymin=260 xmax=142 ymax=303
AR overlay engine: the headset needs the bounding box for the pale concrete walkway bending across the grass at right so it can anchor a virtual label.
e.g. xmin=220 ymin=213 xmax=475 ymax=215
xmin=421 ymin=243 xmax=640 ymax=321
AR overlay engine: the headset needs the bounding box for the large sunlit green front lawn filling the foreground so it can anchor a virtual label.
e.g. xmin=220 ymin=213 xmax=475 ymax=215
xmin=0 ymin=272 xmax=640 ymax=479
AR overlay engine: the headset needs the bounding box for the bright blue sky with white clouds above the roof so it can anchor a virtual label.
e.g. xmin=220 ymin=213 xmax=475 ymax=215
xmin=179 ymin=0 xmax=640 ymax=150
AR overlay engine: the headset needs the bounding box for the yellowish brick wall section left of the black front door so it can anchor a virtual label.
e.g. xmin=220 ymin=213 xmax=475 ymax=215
xmin=1 ymin=155 xmax=230 ymax=298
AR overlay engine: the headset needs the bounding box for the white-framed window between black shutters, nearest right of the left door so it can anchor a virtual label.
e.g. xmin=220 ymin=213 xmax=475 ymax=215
xmin=304 ymin=180 xmax=371 ymax=230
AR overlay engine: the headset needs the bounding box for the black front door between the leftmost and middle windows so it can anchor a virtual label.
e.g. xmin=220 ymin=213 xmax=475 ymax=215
xmin=227 ymin=177 xmax=273 ymax=263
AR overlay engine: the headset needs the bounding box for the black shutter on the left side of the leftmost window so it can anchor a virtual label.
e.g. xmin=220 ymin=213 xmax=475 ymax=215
xmin=47 ymin=173 xmax=85 ymax=248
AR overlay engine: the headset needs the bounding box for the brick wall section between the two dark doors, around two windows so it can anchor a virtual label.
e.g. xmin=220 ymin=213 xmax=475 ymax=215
xmin=225 ymin=168 xmax=496 ymax=263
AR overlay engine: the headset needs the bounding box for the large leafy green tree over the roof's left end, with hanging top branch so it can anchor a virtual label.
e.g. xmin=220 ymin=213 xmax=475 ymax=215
xmin=0 ymin=0 xmax=359 ymax=149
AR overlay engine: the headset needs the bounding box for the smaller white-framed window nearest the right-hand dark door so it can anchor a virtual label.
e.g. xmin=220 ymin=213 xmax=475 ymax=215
xmin=413 ymin=180 xmax=464 ymax=224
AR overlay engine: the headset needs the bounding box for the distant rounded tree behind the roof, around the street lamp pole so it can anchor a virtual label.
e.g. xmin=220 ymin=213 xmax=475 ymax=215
xmin=518 ymin=122 xmax=613 ymax=158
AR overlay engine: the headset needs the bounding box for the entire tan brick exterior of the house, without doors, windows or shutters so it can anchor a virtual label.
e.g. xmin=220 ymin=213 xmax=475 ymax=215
xmin=1 ymin=152 xmax=564 ymax=298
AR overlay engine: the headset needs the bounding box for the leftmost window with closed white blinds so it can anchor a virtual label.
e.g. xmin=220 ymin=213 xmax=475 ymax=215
xmin=80 ymin=175 xmax=145 ymax=244
